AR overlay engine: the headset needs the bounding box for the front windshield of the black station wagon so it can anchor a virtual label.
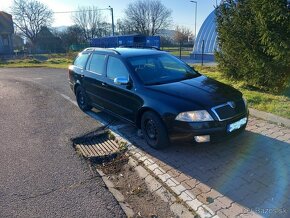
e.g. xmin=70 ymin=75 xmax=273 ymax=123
xmin=128 ymin=54 xmax=200 ymax=85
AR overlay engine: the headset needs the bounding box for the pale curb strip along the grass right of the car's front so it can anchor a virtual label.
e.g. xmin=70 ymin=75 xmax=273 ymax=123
xmin=249 ymin=108 xmax=290 ymax=128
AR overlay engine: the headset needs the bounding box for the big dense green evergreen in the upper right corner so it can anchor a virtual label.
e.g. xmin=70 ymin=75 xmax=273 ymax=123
xmin=216 ymin=0 xmax=290 ymax=92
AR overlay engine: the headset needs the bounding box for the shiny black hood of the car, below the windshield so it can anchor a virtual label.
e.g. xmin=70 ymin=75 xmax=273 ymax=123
xmin=147 ymin=76 xmax=242 ymax=108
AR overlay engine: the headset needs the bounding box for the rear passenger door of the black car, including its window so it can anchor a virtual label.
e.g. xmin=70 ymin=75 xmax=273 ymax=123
xmin=83 ymin=53 xmax=107 ymax=107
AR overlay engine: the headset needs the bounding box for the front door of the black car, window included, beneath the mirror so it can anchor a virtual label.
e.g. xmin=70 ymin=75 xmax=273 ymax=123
xmin=103 ymin=56 xmax=142 ymax=122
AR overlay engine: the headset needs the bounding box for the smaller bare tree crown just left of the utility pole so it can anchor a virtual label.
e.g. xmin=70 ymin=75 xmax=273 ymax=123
xmin=72 ymin=6 xmax=106 ymax=41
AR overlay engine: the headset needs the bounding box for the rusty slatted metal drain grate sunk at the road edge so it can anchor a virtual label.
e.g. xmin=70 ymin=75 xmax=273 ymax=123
xmin=75 ymin=134 xmax=121 ymax=158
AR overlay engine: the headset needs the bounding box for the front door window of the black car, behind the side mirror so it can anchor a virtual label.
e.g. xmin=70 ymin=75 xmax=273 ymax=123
xmin=107 ymin=57 xmax=129 ymax=80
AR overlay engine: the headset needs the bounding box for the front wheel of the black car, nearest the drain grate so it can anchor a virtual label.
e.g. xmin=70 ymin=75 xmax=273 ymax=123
xmin=141 ymin=111 xmax=169 ymax=149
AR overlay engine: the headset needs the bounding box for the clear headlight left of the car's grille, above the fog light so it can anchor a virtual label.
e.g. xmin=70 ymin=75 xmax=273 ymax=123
xmin=175 ymin=110 xmax=213 ymax=122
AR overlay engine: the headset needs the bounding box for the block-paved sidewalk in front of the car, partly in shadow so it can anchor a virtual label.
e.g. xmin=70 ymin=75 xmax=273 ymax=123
xmin=88 ymin=109 xmax=290 ymax=218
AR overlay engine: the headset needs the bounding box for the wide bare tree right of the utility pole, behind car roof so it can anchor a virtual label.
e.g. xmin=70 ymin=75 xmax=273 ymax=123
xmin=125 ymin=0 xmax=171 ymax=35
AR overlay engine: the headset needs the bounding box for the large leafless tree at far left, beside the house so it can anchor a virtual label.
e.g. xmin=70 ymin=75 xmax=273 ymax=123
xmin=12 ymin=0 xmax=53 ymax=46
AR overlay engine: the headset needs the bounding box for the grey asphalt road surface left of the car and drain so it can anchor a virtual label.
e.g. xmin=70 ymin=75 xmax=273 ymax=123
xmin=0 ymin=68 xmax=125 ymax=217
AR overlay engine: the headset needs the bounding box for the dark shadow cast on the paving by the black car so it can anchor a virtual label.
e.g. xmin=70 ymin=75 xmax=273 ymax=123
xmin=85 ymin=112 xmax=290 ymax=217
